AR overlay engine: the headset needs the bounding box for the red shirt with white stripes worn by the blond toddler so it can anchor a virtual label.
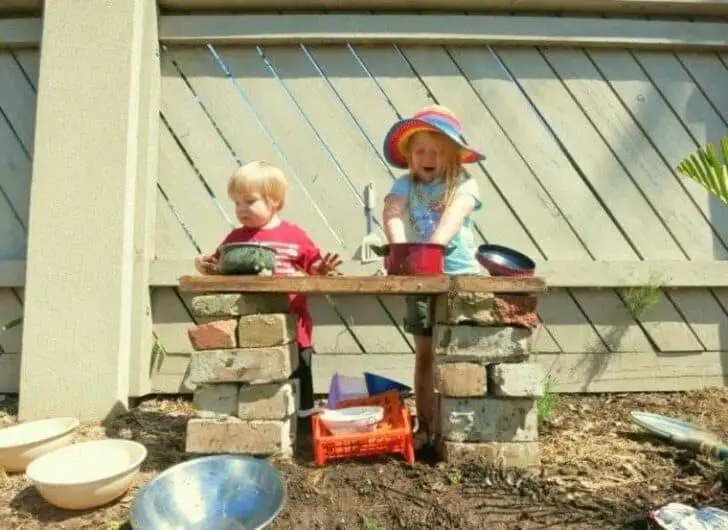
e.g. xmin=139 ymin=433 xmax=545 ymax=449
xmin=213 ymin=221 xmax=321 ymax=348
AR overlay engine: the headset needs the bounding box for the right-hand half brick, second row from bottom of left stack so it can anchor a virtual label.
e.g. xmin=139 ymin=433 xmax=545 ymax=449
xmin=237 ymin=379 xmax=299 ymax=420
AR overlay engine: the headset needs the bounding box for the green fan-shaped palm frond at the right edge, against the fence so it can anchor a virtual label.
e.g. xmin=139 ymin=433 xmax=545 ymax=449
xmin=677 ymin=136 xmax=728 ymax=204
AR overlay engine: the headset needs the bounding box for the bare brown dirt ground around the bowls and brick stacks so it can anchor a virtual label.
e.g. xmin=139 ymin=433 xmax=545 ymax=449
xmin=0 ymin=389 xmax=728 ymax=530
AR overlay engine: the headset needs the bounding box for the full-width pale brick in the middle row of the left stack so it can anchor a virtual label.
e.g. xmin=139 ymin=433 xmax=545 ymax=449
xmin=188 ymin=343 xmax=298 ymax=386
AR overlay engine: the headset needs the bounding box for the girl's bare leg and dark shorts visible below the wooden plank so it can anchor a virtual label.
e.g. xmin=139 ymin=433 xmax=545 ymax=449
xmin=404 ymin=296 xmax=435 ymax=441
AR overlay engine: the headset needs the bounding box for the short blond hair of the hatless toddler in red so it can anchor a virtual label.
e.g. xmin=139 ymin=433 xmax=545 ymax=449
xmin=228 ymin=160 xmax=288 ymax=210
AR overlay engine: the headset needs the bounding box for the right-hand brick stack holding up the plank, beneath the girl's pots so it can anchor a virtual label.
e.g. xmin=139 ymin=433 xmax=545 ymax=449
xmin=434 ymin=293 xmax=544 ymax=470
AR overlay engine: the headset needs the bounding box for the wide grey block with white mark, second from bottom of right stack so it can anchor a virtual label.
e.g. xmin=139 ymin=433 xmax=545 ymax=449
xmin=440 ymin=396 xmax=538 ymax=442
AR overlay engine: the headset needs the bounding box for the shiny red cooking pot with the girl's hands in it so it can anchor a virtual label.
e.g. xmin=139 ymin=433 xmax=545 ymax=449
xmin=372 ymin=243 xmax=453 ymax=276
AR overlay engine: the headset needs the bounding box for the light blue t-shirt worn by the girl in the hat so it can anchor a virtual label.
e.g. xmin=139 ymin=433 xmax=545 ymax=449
xmin=389 ymin=175 xmax=482 ymax=275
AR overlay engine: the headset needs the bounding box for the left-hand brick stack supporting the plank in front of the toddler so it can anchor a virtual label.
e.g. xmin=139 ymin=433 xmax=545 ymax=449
xmin=186 ymin=294 xmax=299 ymax=456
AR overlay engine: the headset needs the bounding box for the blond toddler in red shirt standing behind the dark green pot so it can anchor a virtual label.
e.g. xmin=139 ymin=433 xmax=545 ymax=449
xmin=195 ymin=161 xmax=341 ymax=416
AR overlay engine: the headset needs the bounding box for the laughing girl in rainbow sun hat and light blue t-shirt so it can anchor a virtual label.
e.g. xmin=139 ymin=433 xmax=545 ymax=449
xmin=383 ymin=106 xmax=485 ymax=445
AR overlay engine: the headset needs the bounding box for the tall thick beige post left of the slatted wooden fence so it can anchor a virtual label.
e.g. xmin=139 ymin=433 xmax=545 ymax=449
xmin=19 ymin=0 xmax=159 ymax=420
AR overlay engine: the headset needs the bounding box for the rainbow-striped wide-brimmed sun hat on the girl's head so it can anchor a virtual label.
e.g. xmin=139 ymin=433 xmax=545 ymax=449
xmin=384 ymin=105 xmax=485 ymax=169
